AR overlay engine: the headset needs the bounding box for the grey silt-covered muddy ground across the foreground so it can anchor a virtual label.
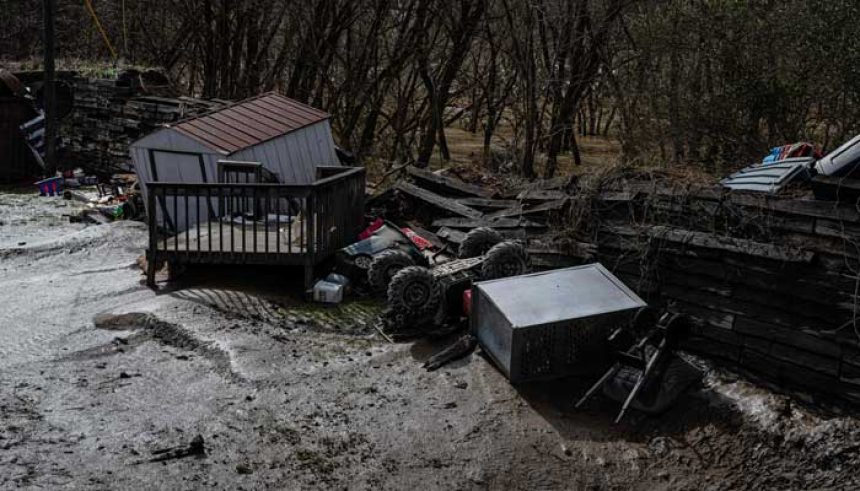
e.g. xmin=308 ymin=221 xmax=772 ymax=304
xmin=0 ymin=189 xmax=860 ymax=490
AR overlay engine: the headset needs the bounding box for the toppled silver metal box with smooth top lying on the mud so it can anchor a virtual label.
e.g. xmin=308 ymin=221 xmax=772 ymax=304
xmin=471 ymin=264 xmax=646 ymax=382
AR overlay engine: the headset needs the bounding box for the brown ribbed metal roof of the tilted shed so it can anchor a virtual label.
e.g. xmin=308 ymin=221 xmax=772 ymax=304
xmin=173 ymin=92 xmax=330 ymax=154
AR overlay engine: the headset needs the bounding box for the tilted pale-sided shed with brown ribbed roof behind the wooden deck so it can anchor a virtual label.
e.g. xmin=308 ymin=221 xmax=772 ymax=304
xmin=130 ymin=93 xmax=340 ymax=206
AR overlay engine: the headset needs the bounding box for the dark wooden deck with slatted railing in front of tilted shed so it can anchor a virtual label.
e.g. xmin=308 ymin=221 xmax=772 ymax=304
xmin=146 ymin=167 xmax=365 ymax=285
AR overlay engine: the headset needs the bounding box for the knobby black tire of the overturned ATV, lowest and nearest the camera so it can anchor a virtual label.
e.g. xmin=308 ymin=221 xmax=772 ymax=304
xmin=388 ymin=266 xmax=442 ymax=324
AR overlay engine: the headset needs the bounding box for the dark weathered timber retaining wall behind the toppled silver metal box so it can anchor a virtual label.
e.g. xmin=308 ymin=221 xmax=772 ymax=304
xmin=591 ymin=183 xmax=860 ymax=403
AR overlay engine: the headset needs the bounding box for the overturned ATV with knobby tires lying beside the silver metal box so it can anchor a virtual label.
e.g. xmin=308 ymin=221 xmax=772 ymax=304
xmin=386 ymin=237 xmax=531 ymax=334
